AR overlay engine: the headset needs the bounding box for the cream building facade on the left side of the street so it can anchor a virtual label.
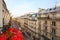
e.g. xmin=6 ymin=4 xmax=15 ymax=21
xmin=0 ymin=0 xmax=10 ymax=30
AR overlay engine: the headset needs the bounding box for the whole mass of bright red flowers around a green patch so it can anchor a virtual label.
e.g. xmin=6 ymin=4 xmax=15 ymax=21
xmin=0 ymin=28 xmax=23 ymax=40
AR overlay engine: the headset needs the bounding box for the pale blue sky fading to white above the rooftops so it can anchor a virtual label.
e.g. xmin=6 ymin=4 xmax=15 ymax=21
xmin=5 ymin=0 xmax=60 ymax=17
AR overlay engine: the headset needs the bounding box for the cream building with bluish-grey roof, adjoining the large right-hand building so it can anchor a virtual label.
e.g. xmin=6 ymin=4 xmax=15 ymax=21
xmin=28 ymin=13 xmax=38 ymax=40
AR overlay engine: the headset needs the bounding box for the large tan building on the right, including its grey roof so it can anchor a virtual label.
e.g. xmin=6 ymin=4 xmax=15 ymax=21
xmin=37 ymin=7 xmax=60 ymax=40
